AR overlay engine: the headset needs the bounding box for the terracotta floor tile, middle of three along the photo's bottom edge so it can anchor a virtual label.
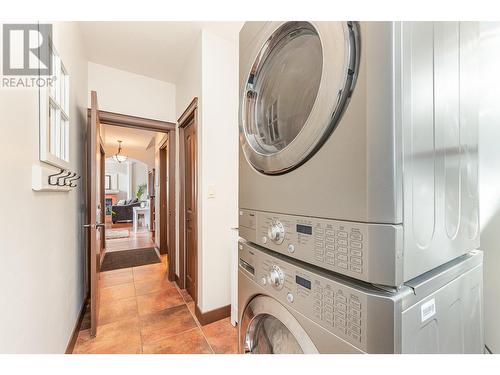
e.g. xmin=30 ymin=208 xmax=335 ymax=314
xmin=142 ymin=328 xmax=212 ymax=354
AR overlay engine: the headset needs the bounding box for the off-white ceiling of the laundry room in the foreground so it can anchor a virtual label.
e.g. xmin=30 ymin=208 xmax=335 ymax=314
xmin=80 ymin=22 xmax=243 ymax=83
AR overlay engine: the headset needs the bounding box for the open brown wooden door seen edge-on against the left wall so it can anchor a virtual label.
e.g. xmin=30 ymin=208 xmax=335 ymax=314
xmin=85 ymin=91 xmax=105 ymax=336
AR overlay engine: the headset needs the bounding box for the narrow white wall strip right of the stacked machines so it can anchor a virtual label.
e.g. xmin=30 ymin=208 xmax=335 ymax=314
xmin=479 ymin=22 xmax=500 ymax=353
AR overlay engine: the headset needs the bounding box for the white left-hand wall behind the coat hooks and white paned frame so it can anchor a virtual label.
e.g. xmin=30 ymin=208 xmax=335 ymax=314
xmin=0 ymin=23 xmax=87 ymax=353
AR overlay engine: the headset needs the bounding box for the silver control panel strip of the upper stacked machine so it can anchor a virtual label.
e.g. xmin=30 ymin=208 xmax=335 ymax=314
xmin=239 ymin=210 xmax=403 ymax=285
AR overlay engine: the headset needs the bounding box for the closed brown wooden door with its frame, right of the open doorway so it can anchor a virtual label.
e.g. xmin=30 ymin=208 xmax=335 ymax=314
xmin=178 ymin=98 xmax=198 ymax=303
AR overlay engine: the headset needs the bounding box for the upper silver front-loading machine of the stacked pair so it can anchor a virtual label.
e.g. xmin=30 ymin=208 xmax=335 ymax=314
xmin=239 ymin=22 xmax=479 ymax=286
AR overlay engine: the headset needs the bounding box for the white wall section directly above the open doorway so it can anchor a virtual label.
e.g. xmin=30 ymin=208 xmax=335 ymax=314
xmin=88 ymin=62 xmax=176 ymax=122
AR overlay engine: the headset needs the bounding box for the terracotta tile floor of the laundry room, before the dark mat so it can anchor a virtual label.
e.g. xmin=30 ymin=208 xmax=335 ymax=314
xmin=73 ymin=254 xmax=238 ymax=354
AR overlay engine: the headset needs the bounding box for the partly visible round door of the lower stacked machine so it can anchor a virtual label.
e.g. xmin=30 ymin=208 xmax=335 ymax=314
xmin=240 ymin=296 xmax=318 ymax=354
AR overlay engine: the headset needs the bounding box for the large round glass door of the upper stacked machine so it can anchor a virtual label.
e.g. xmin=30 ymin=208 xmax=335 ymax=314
xmin=240 ymin=22 xmax=359 ymax=174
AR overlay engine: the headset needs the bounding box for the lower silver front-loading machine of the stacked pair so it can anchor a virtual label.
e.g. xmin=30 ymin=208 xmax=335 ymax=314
xmin=238 ymin=242 xmax=484 ymax=354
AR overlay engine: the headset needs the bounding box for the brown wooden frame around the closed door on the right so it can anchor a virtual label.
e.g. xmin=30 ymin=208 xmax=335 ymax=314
xmin=177 ymin=97 xmax=199 ymax=294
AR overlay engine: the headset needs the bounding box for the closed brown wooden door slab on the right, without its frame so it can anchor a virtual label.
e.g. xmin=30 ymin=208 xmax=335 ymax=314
xmin=184 ymin=121 xmax=197 ymax=301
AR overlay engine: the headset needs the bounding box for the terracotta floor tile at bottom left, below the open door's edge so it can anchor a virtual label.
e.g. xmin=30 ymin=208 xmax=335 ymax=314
xmin=73 ymin=318 xmax=142 ymax=354
